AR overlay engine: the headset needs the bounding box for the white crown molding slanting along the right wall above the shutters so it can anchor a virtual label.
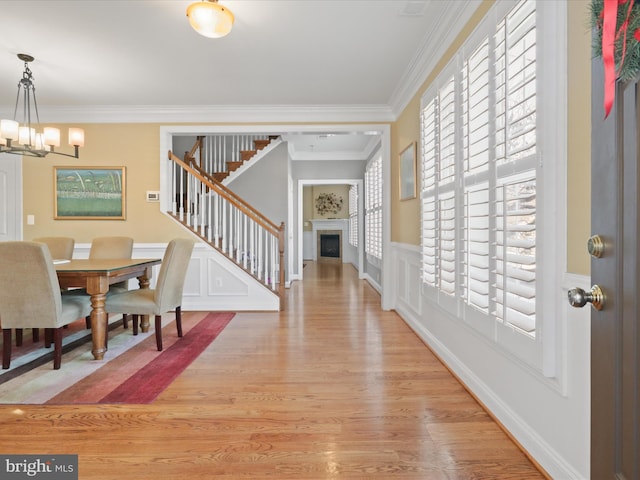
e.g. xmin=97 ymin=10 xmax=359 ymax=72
xmin=389 ymin=0 xmax=482 ymax=116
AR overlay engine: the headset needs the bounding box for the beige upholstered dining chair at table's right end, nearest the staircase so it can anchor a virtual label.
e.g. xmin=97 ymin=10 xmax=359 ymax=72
xmin=105 ymin=238 xmax=195 ymax=351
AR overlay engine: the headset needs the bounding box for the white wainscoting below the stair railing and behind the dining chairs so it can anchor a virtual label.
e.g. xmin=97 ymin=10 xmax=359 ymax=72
xmin=73 ymin=241 xmax=279 ymax=312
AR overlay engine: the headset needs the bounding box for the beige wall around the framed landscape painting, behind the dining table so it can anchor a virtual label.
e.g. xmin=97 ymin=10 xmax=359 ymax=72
xmin=23 ymin=124 xmax=188 ymax=243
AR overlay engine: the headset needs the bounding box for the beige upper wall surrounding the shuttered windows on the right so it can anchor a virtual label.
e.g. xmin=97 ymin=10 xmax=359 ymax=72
xmin=391 ymin=0 xmax=591 ymax=275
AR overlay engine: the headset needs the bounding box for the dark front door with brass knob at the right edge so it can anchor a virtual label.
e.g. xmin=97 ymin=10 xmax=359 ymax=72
xmin=592 ymin=55 xmax=640 ymax=480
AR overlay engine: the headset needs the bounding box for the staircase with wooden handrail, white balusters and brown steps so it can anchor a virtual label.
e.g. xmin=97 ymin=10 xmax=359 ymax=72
xmin=167 ymin=135 xmax=285 ymax=310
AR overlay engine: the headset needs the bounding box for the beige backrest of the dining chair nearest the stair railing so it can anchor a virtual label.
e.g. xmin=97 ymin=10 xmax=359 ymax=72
xmin=154 ymin=238 xmax=195 ymax=313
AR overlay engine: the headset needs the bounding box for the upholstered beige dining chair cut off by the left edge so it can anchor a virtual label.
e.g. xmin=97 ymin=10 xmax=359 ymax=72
xmin=0 ymin=242 xmax=91 ymax=370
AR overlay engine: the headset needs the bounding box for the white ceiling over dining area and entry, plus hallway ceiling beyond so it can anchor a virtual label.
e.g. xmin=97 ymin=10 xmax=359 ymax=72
xmin=0 ymin=0 xmax=480 ymax=159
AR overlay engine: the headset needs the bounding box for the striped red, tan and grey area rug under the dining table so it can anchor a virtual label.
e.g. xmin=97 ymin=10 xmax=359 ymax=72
xmin=0 ymin=312 xmax=234 ymax=404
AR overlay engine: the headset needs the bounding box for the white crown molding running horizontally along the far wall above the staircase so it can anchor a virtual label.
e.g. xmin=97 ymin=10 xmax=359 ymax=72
xmin=0 ymin=105 xmax=394 ymax=123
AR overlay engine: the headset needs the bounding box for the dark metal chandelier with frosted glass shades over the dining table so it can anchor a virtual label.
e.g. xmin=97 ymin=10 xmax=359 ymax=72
xmin=0 ymin=53 xmax=84 ymax=158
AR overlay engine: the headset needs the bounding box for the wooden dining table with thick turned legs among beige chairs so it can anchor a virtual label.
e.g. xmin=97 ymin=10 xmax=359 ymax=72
xmin=54 ymin=258 xmax=162 ymax=360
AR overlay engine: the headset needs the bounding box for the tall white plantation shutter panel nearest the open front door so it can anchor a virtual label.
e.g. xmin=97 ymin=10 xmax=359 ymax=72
xmin=494 ymin=2 xmax=537 ymax=332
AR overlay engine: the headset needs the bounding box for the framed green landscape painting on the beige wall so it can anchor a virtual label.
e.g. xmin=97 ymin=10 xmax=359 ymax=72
xmin=53 ymin=167 xmax=126 ymax=220
